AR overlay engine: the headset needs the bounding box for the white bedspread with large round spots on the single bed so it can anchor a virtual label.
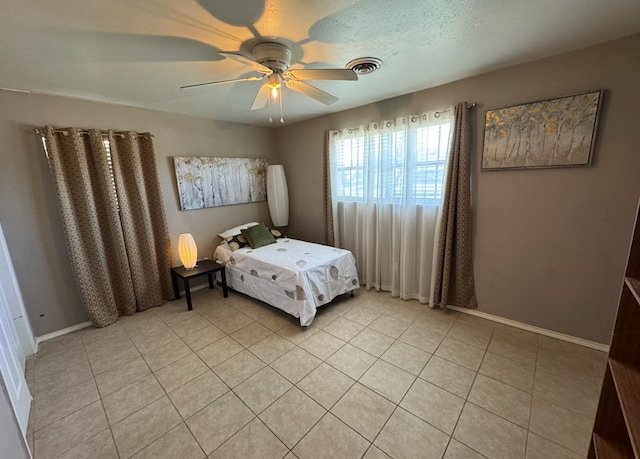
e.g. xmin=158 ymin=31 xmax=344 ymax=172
xmin=214 ymin=239 xmax=360 ymax=326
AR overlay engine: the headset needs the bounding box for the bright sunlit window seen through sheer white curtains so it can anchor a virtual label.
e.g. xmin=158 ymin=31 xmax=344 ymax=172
xmin=331 ymin=120 xmax=451 ymax=205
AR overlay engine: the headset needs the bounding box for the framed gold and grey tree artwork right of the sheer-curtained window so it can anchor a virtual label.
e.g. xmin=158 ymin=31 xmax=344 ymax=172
xmin=482 ymin=91 xmax=602 ymax=171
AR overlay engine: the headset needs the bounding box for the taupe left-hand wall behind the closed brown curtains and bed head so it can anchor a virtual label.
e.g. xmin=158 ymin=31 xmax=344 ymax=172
xmin=0 ymin=90 xmax=275 ymax=336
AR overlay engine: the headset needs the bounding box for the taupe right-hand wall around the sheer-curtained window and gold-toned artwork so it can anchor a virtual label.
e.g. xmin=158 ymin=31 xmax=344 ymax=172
xmin=277 ymin=35 xmax=640 ymax=343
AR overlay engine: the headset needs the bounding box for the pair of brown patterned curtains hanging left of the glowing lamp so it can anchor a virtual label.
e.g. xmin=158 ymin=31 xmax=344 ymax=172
xmin=44 ymin=127 xmax=171 ymax=327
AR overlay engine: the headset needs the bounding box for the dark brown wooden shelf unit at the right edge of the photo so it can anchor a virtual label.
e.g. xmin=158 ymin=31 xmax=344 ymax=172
xmin=589 ymin=205 xmax=640 ymax=459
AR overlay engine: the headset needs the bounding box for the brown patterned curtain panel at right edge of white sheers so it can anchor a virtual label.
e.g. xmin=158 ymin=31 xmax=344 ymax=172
xmin=432 ymin=102 xmax=478 ymax=308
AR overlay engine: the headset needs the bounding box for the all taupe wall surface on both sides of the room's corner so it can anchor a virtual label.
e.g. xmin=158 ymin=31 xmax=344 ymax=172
xmin=0 ymin=35 xmax=640 ymax=343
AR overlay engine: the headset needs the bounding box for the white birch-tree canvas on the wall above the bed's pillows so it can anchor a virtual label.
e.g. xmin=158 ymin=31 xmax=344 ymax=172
xmin=173 ymin=156 xmax=267 ymax=210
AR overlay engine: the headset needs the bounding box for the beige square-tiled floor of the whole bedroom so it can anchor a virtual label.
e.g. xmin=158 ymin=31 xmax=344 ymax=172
xmin=27 ymin=288 xmax=606 ymax=459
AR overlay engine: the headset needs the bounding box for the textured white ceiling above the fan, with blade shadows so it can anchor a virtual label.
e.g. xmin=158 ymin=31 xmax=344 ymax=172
xmin=0 ymin=0 xmax=640 ymax=125
